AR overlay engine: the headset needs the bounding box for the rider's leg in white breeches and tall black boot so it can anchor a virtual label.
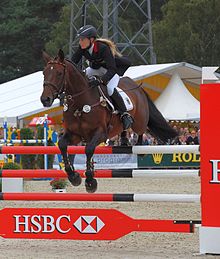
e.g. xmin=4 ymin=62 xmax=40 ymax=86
xmin=107 ymin=74 xmax=134 ymax=130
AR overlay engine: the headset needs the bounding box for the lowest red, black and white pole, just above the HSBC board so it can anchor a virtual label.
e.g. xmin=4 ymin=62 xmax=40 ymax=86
xmin=0 ymin=193 xmax=200 ymax=203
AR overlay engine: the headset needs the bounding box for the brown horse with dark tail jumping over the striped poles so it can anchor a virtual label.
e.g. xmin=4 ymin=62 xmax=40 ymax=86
xmin=41 ymin=50 xmax=177 ymax=192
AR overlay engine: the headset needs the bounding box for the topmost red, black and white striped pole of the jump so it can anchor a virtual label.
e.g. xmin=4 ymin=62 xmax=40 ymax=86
xmin=0 ymin=145 xmax=199 ymax=154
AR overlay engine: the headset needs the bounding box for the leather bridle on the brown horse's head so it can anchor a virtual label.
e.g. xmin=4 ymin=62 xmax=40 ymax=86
xmin=43 ymin=60 xmax=66 ymax=99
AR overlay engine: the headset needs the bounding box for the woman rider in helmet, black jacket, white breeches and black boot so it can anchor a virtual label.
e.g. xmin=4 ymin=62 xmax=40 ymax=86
xmin=72 ymin=25 xmax=133 ymax=130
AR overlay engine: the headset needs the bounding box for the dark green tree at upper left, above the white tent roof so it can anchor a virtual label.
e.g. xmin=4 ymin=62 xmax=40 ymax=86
xmin=0 ymin=0 xmax=69 ymax=83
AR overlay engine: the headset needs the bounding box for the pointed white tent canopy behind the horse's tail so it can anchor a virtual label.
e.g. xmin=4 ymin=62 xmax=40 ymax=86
xmin=155 ymin=73 xmax=200 ymax=120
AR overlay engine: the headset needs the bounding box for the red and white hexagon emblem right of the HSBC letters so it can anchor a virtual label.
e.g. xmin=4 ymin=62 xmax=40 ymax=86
xmin=73 ymin=216 xmax=105 ymax=234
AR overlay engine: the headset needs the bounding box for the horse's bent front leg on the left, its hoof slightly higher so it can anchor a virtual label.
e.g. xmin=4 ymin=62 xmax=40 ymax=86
xmin=58 ymin=132 xmax=82 ymax=186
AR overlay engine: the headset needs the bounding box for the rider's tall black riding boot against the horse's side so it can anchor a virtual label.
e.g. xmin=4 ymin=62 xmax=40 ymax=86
xmin=110 ymin=89 xmax=134 ymax=130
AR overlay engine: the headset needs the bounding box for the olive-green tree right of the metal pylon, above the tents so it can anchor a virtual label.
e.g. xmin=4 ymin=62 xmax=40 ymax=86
xmin=153 ymin=0 xmax=220 ymax=66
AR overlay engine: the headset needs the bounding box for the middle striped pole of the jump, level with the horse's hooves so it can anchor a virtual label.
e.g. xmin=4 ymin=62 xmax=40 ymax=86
xmin=0 ymin=169 xmax=199 ymax=178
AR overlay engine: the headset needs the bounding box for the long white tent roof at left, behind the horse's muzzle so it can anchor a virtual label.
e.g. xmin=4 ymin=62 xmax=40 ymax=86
xmin=0 ymin=71 xmax=59 ymax=125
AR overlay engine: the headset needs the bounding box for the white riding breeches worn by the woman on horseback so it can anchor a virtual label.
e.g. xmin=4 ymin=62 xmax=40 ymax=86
xmin=86 ymin=67 xmax=120 ymax=96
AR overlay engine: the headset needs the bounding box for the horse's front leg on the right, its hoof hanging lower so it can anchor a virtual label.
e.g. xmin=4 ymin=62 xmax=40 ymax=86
xmin=85 ymin=131 xmax=107 ymax=193
